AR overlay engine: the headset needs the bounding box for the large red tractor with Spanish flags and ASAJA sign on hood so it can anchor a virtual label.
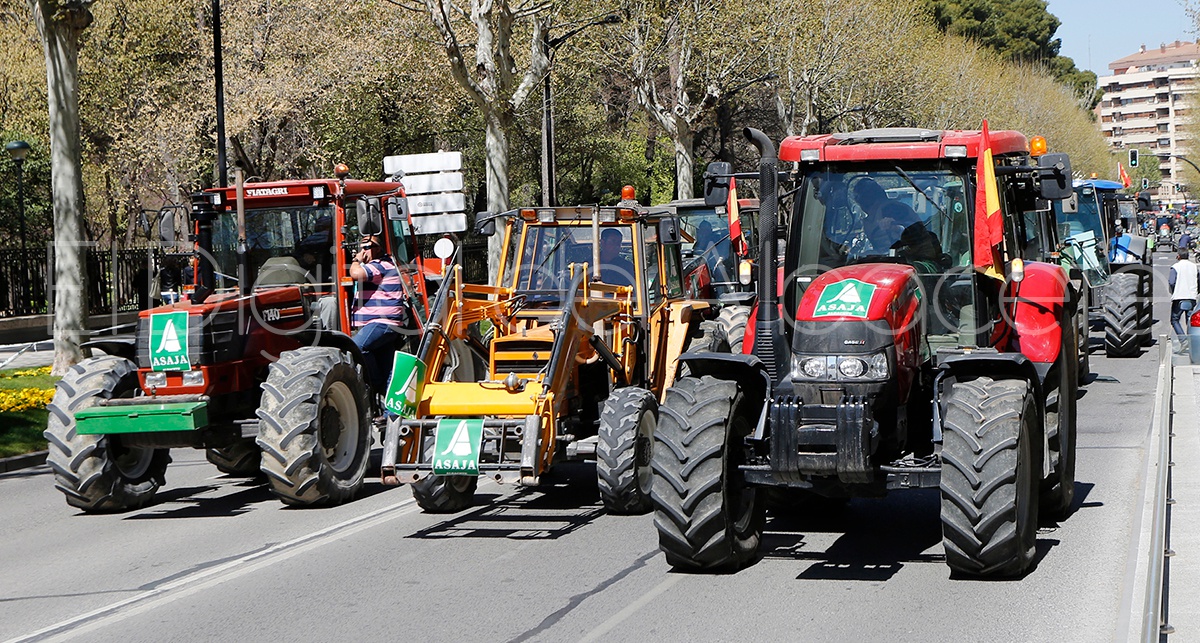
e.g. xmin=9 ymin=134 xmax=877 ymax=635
xmin=652 ymin=128 xmax=1079 ymax=576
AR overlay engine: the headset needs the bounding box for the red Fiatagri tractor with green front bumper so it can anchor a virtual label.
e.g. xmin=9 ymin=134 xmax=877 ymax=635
xmin=46 ymin=166 xmax=463 ymax=512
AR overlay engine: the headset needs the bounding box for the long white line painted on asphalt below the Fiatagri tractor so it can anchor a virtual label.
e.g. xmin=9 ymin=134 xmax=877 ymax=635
xmin=6 ymin=498 xmax=416 ymax=643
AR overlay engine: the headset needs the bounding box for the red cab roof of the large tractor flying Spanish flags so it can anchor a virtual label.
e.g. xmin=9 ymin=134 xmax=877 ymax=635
xmin=779 ymin=127 xmax=1030 ymax=162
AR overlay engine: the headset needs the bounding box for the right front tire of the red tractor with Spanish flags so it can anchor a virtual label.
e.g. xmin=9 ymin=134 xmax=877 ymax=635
xmin=941 ymin=378 xmax=1042 ymax=576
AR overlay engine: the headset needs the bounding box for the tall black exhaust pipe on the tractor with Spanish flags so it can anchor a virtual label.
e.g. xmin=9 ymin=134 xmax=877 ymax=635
xmin=742 ymin=127 xmax=787 ymax=383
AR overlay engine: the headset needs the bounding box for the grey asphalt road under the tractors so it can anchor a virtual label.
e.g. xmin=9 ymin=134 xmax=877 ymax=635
xmin=0 ymin=262 xmax=1166 ymax=642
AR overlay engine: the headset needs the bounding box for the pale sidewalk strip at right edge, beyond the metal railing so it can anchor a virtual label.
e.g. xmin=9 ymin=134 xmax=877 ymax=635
xmin=1164 ymin=364 xmax=1200 ymax=641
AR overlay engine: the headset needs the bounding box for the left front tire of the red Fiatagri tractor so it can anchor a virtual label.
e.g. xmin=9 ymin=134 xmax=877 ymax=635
xmin=44 ymin=356 xmax=170 ymax=513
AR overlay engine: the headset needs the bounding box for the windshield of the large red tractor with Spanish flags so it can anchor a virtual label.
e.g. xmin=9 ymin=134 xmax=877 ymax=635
xmin=785 ymin=161 xmax=976 ymax=345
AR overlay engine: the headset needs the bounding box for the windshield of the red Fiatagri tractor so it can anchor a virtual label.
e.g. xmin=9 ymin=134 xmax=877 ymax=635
xmin=212 ymin=205 xmax=334 ymax=287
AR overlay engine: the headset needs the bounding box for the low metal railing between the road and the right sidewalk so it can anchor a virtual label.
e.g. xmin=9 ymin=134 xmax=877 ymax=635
xmin=1141 ymin=335 xmax=1175 ymax=643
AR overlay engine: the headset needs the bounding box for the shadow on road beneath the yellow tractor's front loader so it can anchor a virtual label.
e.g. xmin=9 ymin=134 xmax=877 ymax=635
xmin=407 ymin=464 xmax=604 ymax=540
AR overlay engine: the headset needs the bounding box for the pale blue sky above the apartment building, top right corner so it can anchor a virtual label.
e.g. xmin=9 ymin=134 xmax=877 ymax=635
xmin=1049 ymin=0 xmax=1200 ymax=76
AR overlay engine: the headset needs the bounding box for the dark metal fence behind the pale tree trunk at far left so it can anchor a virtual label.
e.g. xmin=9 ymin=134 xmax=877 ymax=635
xmin=0 ymin=246 xmax=157 ymax=318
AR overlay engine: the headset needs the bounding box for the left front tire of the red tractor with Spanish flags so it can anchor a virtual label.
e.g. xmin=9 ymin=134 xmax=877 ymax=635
xmin=650 ymin=375 xmax=766 ymax=570
